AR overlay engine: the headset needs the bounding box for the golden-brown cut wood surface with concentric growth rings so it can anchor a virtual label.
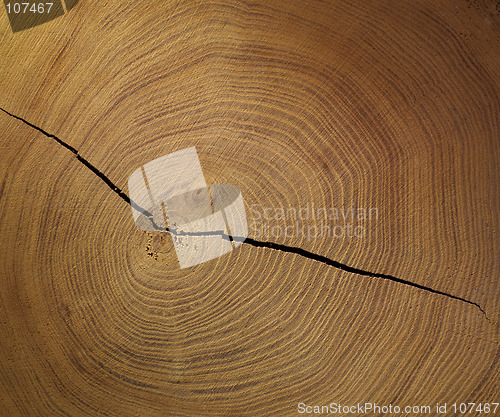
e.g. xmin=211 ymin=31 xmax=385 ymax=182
xmin=0 ymin=0 xmax=500 ymax=417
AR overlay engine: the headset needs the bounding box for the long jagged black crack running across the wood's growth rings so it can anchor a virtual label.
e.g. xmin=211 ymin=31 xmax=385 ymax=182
xmin=0 ymin=107 xmax=489 ymax=320
